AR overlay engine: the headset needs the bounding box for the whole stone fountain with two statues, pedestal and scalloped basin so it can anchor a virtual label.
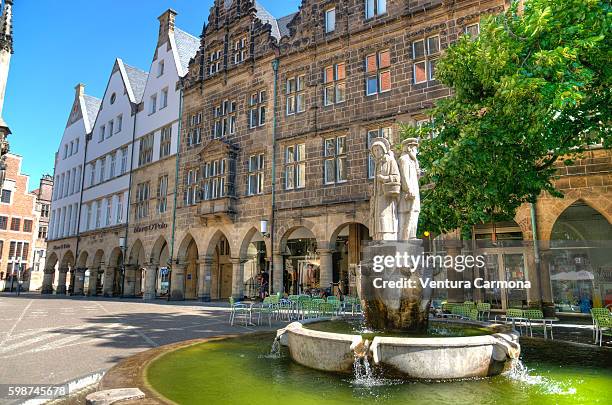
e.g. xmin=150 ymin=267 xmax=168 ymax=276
xmin=277 ymin=138 xmax=520 ymax=380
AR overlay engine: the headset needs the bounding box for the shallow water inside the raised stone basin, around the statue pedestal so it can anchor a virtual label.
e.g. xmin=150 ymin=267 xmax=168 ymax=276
xmin=304 ymin=319 xmax=493 ymax=341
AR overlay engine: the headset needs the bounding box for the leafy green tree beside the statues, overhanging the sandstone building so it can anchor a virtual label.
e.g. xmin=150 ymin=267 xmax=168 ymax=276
xmin=402 ymin=0 xmax=612 ymax=233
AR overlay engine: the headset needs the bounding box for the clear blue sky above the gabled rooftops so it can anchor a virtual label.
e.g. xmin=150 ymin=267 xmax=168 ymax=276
xmin=4 ymin=0 xmax=300 ymax=189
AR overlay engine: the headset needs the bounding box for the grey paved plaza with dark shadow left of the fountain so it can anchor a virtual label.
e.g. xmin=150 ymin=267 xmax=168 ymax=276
xmin=0 ymin=293 xmax=281 ymax=384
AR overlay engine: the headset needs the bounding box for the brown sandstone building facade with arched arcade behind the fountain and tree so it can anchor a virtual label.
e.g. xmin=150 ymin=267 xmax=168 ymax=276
xmin=46 ymin=0 xmax=612 ymax=312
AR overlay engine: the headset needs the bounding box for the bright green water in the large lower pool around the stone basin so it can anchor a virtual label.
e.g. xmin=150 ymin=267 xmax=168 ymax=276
xmin=146 ymin=333 xmax=612 ymax=405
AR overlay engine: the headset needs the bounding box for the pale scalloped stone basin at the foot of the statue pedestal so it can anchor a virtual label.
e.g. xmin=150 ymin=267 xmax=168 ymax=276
xmin=277 ymin=319 xmax=520 ymax=380
